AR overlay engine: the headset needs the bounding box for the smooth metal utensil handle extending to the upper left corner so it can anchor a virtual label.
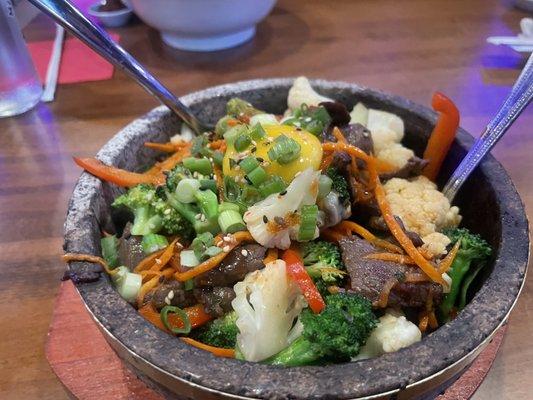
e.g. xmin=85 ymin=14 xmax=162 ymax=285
xmin=30 ymin=0 xmax=209 ymax=134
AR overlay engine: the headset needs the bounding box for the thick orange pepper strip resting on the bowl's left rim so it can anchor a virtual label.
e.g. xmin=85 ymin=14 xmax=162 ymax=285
xmin=73 ymin=157 xmax=156 ymax=187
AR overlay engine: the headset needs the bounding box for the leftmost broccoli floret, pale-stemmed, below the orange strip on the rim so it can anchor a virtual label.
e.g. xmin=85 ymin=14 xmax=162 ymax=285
xmin=113 ymin=184 xmax=163 ymax=235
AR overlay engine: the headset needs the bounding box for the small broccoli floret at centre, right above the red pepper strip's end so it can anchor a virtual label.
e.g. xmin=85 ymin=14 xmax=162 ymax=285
xmin=300 ymin=240 xmax=346 ymax=284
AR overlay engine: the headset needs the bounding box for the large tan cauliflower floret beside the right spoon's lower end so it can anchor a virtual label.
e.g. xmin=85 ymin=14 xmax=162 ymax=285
xmin=383 ymin=176 xmax=461 ymax=240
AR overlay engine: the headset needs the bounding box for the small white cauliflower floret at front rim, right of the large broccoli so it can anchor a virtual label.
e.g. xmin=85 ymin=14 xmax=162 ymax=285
xmin=356 ymin=311 xmax=422 ymax=360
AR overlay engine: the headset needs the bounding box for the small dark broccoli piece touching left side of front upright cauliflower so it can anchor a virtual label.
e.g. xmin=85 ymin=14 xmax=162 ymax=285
xmin=195 ymin=311 xmax=239 ymax=349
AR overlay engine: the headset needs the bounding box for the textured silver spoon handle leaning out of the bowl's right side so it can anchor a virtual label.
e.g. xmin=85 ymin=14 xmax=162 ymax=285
xmin=443 ymin=54 xmax=533 ymax=203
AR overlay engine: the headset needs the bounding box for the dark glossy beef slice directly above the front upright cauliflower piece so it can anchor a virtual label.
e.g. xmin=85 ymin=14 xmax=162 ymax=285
xmin=194 ymin=244 xmax=267 ymax=286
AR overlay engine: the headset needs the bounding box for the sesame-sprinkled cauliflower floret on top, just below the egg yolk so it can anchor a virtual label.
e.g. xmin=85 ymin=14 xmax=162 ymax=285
xmin=243 ymin=168 xmax=320 ymax=249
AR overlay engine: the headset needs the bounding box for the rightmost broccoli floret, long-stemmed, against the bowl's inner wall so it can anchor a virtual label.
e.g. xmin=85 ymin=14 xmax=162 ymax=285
xmin=440 ymin=228 xmax=492 ymax=321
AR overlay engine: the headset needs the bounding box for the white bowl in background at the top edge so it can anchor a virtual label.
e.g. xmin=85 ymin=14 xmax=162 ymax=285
xmin=129 ymin=0 xmax=276 ymax=51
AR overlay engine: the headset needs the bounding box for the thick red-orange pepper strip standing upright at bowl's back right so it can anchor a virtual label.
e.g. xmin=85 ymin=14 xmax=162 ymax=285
xmin=423 ymin=92 xmax=460 ymax=181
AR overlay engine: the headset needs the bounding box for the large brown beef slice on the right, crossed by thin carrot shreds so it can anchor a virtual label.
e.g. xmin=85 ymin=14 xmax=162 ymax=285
xmin=339 ymin=236 xmax=442 ymax=307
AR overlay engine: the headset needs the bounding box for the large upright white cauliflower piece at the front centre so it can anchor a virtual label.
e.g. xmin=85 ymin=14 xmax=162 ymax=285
xmin=231 ymin=260 xmax=305 ymax=361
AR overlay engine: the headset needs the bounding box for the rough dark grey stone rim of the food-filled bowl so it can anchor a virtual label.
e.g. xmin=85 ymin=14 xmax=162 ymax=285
xmin=65 ymin=78 xmax=529 ymax=399
